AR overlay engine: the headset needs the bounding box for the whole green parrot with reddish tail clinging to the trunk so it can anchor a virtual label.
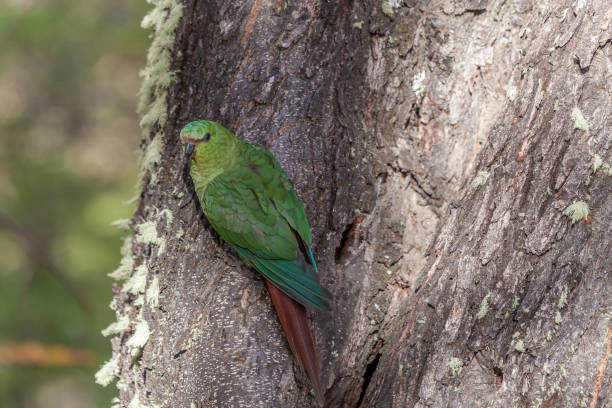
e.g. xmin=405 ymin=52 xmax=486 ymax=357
xmin=180 ymin=120 xmax=331 ymax=402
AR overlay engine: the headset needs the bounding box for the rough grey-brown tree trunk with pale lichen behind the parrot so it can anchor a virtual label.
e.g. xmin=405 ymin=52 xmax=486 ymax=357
xmin=98 ymin=0 xmax=612 ymax=408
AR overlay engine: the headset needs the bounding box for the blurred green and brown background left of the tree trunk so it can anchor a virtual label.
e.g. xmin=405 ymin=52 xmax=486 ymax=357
xmin=0 ymin=0 xmax=149 ymax=408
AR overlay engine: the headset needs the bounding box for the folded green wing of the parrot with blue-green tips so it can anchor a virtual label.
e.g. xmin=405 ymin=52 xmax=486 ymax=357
xmin=201 ymin=147 xmax=330 ymax=310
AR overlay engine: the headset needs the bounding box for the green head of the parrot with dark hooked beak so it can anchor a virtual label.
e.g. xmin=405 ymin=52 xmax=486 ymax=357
xmin=180 ymin=120 xmax=239 ymax=164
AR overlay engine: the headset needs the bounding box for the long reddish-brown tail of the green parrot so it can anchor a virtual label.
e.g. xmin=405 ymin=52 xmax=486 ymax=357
xmin=266 ymin=279 xmax=325 ymax=404
